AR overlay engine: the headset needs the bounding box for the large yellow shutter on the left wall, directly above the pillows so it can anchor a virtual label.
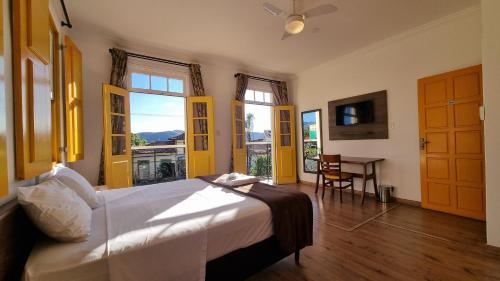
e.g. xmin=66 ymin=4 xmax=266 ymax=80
xmin=12 ymin=0 xmax=52 ymax=179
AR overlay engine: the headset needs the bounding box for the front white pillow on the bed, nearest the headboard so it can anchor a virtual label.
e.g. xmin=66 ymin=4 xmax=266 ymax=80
xmin=17 ymin=178 xmax=92 ymax=241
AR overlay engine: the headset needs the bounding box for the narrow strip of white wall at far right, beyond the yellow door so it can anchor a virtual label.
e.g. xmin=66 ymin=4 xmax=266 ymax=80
xmin=481 ymin=0 xmax=500 ymax=247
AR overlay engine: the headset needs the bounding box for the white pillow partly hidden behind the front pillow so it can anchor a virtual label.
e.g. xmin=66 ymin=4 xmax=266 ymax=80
xmin=52 ymin=166 xmax=99 ymax=209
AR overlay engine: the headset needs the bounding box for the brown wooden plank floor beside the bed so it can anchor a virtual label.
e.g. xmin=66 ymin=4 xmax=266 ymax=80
xmin=250 ymin=185 xmax=500 ymax=281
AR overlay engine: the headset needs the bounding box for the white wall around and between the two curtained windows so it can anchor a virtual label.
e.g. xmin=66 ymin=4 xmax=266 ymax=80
xmin=65 ymin=23 xmax=287 ymax=184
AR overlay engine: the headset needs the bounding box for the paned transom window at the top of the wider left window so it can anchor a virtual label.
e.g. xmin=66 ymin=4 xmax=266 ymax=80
xmin=129 ymin=72 xmax=185 ymax=96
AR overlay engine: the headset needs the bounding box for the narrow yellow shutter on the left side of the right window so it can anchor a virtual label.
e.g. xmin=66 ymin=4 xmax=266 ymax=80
xmin=232 ymin=100 xmax=247 ymax=174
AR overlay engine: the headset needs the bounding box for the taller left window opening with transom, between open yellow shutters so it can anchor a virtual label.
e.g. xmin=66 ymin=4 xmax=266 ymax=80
xmin=128 ymin=65 xmax=189 ymax=185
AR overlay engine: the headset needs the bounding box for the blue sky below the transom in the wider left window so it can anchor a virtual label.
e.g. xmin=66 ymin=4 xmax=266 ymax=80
xmin=130 ymin=92 xmax=185 ymax=133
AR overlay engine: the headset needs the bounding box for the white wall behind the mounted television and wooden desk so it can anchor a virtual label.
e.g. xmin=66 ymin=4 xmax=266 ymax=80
xmin=294 ymin=7 xmax=481 ymax=201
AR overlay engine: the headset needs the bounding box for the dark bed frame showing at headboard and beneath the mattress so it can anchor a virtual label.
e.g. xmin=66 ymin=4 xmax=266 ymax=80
xmin=0 ymin=199 xmax=300 ymax=281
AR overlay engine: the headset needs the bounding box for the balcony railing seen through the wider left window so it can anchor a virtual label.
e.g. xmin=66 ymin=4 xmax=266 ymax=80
xmin=132 ymin=145 xmax=186 ymax=185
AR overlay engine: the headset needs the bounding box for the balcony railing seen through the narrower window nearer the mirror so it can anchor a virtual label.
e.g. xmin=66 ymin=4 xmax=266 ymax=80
xmin=247 ymin=142 xmax=272 ymax=180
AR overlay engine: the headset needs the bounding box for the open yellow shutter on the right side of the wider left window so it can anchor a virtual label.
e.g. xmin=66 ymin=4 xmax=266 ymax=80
xmin=187 ymin=96 xmax=215 ymax=178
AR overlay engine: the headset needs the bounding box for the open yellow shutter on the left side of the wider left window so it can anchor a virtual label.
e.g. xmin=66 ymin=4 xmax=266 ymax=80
xmin=102 ymin=85 xmax=132 ymax=188
